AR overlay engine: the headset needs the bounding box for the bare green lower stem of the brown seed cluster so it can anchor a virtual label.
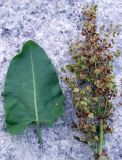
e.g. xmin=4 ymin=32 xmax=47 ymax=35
xmin=98 ymin=119 xmax=104 ymax=160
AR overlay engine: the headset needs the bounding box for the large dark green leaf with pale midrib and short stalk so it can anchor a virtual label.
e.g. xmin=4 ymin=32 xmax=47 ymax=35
xmin=4 ymin=41 xmax=64 ymax=142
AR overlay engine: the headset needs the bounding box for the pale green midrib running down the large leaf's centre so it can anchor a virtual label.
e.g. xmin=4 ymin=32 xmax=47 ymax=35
xmin=30 ymin=47 xmax=39 ymax=125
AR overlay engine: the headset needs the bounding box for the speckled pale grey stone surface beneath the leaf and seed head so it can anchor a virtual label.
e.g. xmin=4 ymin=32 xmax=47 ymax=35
xmin=0 ymin=0 xmax=122 ymax=160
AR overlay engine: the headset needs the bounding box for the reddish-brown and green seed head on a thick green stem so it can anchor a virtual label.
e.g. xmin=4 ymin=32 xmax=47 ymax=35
xmin=63 ymin=5 xmax=119 ymax=160
